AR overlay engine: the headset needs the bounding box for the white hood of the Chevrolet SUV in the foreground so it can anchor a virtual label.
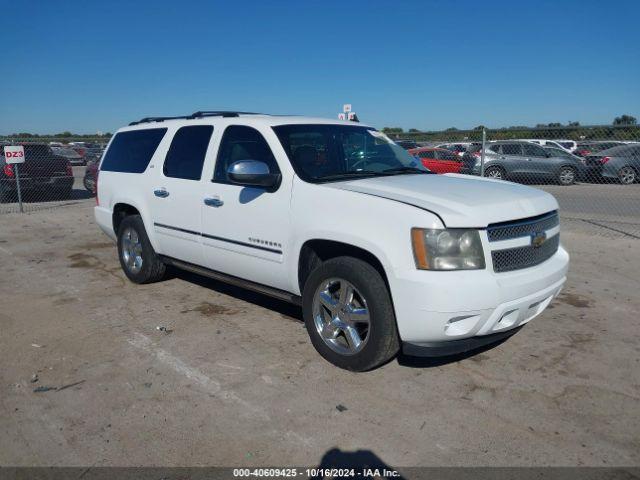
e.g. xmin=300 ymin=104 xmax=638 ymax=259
xmin=324 ymin=174 xmax=558 ymax=228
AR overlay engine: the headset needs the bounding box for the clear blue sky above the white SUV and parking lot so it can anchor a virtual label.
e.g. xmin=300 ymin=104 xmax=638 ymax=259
xmin=0 ymin=0 xmax=640 ymax=134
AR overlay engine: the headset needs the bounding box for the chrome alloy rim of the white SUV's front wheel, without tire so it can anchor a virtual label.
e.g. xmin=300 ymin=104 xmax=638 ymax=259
xmin=312 ymin=278 xmax=370 ymax=355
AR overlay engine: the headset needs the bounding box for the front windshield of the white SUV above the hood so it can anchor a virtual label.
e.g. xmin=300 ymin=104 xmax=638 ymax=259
xmin=273 ymin=125 xmax=429 ymax=182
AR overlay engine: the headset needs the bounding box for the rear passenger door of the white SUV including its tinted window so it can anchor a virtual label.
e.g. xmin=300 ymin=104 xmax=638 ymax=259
xmin=147 ymin=125 xmax=213 ymax=265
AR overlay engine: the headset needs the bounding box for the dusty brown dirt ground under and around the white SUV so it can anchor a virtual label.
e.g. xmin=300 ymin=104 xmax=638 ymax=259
xmin=0 ymin=200 xmax=640 ymax=467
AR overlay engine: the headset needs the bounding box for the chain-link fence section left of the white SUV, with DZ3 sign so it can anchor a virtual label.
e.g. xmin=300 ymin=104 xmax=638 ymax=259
xmin=0 ymin=136 xmax=107 ymax=214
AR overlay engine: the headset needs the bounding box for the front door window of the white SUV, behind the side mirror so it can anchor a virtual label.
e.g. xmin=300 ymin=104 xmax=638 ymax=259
xmin=213 ymin=125 xmax=280 ymax=183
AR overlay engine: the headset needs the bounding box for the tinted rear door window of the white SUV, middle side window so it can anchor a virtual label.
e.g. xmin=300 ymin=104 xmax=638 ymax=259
xmin=162 ymin=125 xmax=213 ymax=180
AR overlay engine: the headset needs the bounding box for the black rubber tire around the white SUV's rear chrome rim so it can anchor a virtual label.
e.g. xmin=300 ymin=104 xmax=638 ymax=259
xmin=118 ymin=215 xmax=166 ymax=283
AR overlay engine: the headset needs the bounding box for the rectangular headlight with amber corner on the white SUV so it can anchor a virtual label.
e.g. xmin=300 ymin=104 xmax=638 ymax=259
xmin=411 ymin=228 xmax=485 ymax=270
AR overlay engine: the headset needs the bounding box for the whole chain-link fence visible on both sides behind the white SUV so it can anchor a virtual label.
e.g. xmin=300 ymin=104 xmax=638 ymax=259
xmin=0 ymin=125 xmax=640 ymax=239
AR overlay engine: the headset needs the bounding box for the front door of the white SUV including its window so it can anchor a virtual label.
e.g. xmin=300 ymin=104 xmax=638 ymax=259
xmin=200 ymin=125 xmax=291 ymax=290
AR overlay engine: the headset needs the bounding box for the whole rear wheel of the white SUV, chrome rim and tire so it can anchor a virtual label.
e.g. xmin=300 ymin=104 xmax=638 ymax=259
xmin=118 ymin=215 xmax=166 ymax=283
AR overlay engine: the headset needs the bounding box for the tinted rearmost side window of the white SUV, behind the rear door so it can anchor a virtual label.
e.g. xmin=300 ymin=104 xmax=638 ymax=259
xmin=100 ymin=128 xmax=167 ymax=173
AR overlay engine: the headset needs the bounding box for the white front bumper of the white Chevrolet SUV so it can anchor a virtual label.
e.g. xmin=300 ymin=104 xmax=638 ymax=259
xmin=390 ymin=247 xmax=569 ymax=346
